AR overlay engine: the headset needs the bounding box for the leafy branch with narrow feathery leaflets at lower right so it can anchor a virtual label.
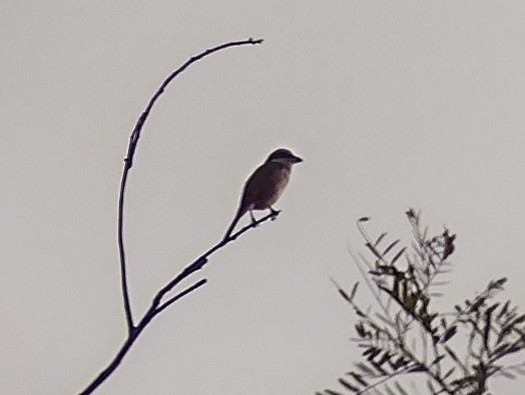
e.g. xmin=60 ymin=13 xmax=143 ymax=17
xmin=317 ymin=209 xmax=525 ymax=395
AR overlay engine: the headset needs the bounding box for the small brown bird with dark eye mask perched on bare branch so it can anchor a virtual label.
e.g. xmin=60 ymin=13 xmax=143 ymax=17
xmin=224 ymin=148 xmax=303 ymax=239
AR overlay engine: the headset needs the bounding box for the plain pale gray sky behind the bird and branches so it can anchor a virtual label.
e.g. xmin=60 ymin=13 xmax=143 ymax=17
xmin=0 ymin=0 xmax=525 ymax=395
